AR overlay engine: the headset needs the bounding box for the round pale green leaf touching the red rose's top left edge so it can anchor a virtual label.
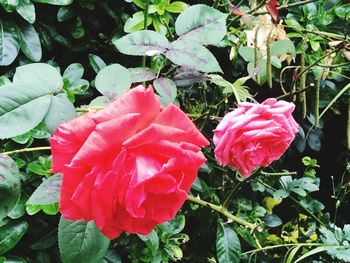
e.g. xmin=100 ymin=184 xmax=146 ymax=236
xmin=95 ymin=64 xmax=131 ymax=100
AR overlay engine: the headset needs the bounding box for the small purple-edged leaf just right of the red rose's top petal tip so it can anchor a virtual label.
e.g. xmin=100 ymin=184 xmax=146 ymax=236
xmin=153 ymin=78 xmax=177 ymax=107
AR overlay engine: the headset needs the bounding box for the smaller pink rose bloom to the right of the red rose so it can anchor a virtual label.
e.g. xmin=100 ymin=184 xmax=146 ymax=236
xmin=214 ymin=98 xmax=299 ymax=177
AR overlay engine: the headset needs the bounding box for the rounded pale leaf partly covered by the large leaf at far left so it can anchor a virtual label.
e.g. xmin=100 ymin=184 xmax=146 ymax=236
xmin=13 ymin=63 xmax=63 ymax=93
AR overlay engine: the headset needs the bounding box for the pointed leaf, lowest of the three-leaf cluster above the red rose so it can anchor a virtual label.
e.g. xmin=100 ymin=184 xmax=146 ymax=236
xmin=165 ymin=40 xmax=222 ymax=72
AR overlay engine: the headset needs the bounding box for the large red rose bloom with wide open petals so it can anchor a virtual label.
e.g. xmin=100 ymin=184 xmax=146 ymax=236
xmin=50 ymin=86 xmax=209 ymax=239
